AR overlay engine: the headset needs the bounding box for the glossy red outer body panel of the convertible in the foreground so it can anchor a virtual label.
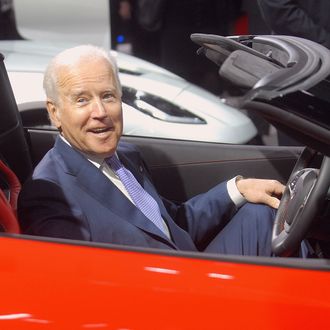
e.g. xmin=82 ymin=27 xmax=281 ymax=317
xmin=0 ymin=236 xmax=330 ymax=330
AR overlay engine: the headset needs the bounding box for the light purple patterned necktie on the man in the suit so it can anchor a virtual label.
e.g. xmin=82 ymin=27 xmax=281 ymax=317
xmin=106 ymin=156 xmax=168 ymax=236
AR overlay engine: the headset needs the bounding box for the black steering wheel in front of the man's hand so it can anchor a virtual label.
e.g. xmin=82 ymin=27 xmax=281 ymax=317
xmin=272 ymin=148 xmax=330 ymax=257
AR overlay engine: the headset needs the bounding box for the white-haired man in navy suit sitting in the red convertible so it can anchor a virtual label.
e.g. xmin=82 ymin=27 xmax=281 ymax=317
xmin=18 ymin=45 xmax=284 ymax=256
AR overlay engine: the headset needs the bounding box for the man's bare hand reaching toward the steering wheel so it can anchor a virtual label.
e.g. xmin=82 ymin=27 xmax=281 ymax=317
xmin=236 ymin=179 xmax=285 ymax=209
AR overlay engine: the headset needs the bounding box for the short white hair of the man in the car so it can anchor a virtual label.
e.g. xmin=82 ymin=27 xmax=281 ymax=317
xmin=43 ymin=45 xmax=122 ymax=102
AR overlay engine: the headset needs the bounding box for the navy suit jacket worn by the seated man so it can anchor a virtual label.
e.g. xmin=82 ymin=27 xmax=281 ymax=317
xmin=18 ymin=138 xmax=236 ymax=251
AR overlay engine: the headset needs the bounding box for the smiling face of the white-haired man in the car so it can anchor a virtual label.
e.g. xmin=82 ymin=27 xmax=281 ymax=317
xmin=47 ymin=58 xmax=123 ymax=158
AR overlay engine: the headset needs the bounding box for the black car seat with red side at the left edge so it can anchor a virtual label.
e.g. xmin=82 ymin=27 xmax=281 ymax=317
xmin=0 ymin=54 xmax=32 ymax=233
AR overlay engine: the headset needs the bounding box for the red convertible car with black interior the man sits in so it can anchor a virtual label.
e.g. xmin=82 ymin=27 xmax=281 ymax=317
xmin=0 ymin=34 xmax=330 ymax=330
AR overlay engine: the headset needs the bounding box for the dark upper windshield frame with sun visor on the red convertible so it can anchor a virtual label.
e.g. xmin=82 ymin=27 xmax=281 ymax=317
xmin=191 ymin=34 xmax=330 ymax=156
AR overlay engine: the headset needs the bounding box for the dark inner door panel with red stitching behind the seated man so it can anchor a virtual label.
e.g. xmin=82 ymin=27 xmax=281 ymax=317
xmin=29 ymin=129 xmax=301 ymax=201
